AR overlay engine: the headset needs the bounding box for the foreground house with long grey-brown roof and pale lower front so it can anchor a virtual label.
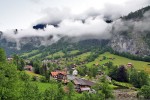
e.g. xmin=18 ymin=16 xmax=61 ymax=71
xmin=73 ymin=78 xmax=95 ymax=92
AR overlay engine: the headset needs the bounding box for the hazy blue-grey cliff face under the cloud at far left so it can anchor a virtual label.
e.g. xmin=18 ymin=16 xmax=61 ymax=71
xmin=0 ymin=32 xmax=57 ymax=55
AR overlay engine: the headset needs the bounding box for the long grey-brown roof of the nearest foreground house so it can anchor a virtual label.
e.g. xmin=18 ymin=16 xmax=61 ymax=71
xmin=73 ymin=78 xmax=95 ymax=86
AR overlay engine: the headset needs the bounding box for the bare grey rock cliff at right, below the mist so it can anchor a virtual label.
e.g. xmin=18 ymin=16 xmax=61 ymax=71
xmin=109 ymin=29 xmax=150 ymax=56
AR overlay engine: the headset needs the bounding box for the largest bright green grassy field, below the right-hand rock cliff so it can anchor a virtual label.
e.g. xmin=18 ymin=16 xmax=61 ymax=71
xmin=87 ymin=52 xmax=150 ymax=73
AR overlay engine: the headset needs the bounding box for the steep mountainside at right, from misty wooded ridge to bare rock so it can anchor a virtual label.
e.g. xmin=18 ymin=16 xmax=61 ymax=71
xmin=109 ymin=6 xmax=150 ymax=56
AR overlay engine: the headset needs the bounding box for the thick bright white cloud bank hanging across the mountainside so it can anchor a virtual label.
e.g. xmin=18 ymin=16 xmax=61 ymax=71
xmin=4 ymin=16 xmax=111 ymax=39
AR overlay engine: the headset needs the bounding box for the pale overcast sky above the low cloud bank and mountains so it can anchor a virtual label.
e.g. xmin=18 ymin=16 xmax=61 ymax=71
xmin=0 ymin=0 xmax=150 ymax=31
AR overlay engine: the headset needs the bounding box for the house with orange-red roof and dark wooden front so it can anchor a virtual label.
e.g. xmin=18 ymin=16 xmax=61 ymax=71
xmin=51 ymin=70 xmax=67 ymax=81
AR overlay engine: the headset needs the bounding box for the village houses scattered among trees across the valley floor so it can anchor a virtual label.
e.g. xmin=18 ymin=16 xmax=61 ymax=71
xmin=8 ymin=55 xmax=133 ymax=93
